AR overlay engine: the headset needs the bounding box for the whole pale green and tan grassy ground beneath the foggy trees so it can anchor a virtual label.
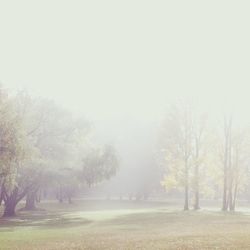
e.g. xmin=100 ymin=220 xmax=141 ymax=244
xmin=0 ymin=201 xmax=250 ymax=250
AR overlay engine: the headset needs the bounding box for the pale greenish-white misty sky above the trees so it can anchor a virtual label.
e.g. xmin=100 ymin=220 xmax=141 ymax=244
xmin=0 ymin=0 xmax=250 ymax=121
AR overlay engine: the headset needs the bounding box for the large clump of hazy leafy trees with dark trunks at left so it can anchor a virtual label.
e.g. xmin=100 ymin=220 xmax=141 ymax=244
xmin=0 ymin=88 xmax=118 ymax=216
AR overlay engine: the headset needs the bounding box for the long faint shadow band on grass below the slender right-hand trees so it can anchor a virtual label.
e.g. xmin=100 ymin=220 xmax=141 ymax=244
xmin=100 ymin=210 xmax=250 ymax=230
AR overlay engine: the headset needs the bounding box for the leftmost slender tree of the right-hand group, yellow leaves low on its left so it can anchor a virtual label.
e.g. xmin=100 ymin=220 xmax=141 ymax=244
xmin=161 ymin=104 xmax=193 ymax=210
